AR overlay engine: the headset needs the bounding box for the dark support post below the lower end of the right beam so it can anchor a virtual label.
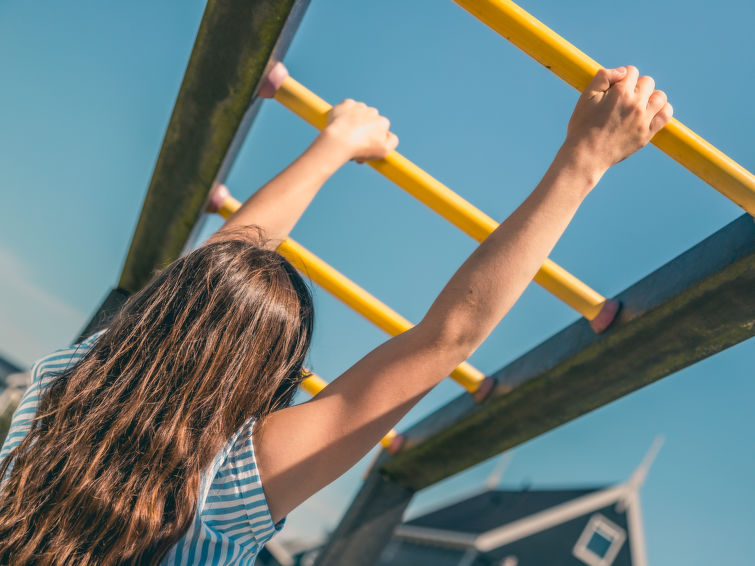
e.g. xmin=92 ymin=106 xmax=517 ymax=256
xmin=315 ymin=464 xmax=414 ymax=566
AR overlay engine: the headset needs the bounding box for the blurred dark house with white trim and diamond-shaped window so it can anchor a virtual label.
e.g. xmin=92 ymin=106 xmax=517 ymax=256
xmin=378 ymin=441 xmax=661 ymax=566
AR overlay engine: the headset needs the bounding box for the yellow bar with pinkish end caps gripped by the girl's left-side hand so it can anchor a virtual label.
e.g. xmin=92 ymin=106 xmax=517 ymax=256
xmin=260 ymin=63 xmax=618 ymax=332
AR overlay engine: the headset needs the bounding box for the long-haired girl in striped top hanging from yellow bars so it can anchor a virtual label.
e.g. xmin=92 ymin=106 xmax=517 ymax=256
xmin=0 ymin=66 xmax=672 ymax=564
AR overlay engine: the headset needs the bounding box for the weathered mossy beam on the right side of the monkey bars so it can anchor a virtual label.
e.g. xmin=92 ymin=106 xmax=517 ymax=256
xmin=384 ymin=215 xmax=755 ymax=490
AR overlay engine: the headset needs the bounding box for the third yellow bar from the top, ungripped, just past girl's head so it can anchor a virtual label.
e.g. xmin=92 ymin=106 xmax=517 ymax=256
xmin=207 ymin=185 xmax=492 ymax=400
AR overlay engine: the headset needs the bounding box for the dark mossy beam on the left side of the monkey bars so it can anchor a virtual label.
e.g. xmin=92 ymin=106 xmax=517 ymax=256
xmin=118 ymin=0 xmax=309 ymax=293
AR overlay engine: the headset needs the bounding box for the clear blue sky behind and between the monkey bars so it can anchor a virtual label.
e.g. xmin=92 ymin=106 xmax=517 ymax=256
xmin=0 ymin=0 xmax=755 ymax=566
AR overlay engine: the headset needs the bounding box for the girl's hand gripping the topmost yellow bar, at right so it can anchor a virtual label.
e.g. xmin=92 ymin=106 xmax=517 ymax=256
xmin=564 ymin=65 xmax=673 ymax=174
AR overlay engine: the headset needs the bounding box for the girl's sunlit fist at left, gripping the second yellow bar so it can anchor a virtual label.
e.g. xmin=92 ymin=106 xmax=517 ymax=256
xmin=320 ymin=98 xmax=398 ymax=163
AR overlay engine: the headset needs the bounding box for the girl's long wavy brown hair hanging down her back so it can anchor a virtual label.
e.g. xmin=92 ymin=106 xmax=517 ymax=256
xmin=0 ymin=237 xmax=313 ymax=565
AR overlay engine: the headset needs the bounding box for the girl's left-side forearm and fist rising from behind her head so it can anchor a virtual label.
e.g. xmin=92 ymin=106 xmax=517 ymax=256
xmin=211 ymin=99 xmax=398 ymax=249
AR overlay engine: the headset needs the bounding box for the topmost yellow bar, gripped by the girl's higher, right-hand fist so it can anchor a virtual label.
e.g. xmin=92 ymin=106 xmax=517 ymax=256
xmin=454 ymin=0 xmax=755 ymax=216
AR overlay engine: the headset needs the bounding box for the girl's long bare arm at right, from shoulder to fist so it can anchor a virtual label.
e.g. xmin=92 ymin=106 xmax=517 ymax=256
xmin=255 ymin=63 xmax=672 ymax=520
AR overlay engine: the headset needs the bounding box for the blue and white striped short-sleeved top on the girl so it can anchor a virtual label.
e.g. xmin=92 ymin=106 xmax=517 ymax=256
xmin=0 ymin=333 xmax=284 ymax=566
